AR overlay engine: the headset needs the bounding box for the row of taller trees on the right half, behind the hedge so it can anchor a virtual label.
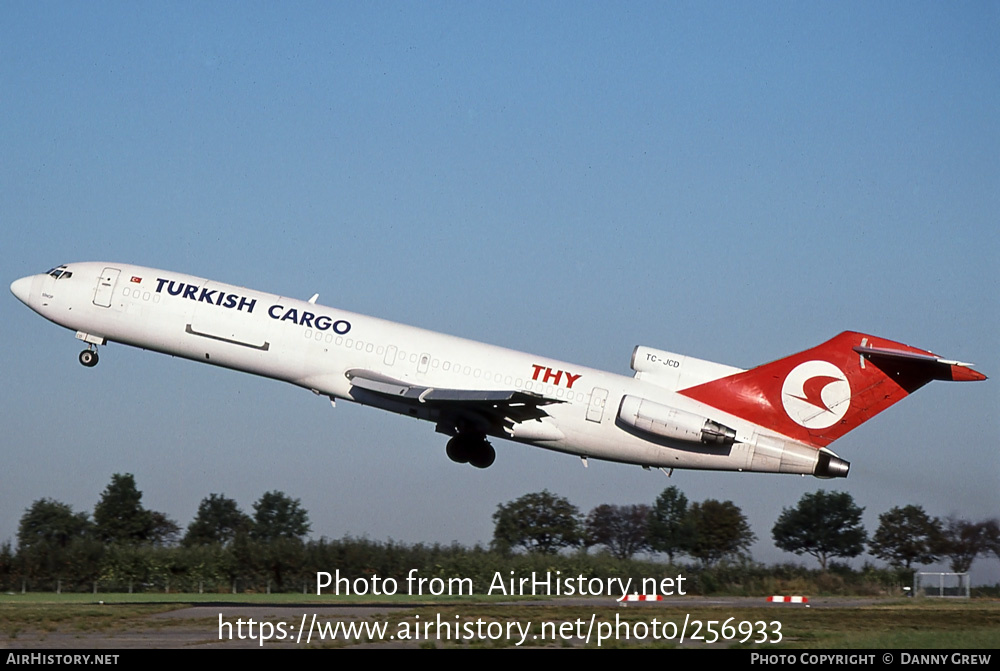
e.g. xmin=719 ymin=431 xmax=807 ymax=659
xmin=493 ymin=486 xmax=1000 ymax=573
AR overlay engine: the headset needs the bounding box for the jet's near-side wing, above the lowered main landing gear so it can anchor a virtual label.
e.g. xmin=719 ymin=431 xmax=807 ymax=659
xmin=347 ymin=369 xmax=563 ymax=423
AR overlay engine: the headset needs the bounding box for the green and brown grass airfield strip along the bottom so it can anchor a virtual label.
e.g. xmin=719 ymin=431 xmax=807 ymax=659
xmin=0 ymin=594 xmax=1000 ymax=650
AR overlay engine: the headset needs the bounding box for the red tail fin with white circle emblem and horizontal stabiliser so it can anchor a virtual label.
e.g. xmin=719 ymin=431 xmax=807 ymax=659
xmin=680 ymin=331 xmax=986 ymax=447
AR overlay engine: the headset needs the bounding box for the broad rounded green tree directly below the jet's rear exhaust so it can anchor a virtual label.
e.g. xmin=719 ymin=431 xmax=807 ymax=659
xmin=771 ymin=489 xmax=868 ymax=571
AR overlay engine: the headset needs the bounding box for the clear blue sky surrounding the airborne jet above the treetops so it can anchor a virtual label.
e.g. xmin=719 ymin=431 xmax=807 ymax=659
xmin=0 ymin=2 xmax=1000 ymax=581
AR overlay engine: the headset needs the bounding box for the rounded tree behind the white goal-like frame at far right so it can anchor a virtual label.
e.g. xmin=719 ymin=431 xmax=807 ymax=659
xmin=868 ymin=505 xmax=942 ymax=569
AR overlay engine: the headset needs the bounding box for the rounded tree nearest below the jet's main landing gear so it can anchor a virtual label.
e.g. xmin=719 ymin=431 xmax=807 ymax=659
xmin=493 ymin=489 xmax=583 ymax=554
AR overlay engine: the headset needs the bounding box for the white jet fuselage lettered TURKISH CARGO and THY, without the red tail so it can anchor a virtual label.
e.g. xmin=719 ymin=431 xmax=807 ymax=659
xmin=11 ymin=263 xmax=832 ymax=473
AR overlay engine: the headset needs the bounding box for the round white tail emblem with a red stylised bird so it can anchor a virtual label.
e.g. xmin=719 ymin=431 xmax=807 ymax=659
xmin=781 ymin=360 xmax=851 ymax=429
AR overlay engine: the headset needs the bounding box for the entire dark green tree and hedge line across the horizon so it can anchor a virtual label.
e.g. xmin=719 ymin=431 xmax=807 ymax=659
xmin=0 ymin=473 xmax=1000 ymax=592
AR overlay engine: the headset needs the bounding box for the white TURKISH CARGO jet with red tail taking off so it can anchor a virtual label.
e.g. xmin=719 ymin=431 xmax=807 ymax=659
xmin=10 ymin=262 xmax=986 ymax=478
